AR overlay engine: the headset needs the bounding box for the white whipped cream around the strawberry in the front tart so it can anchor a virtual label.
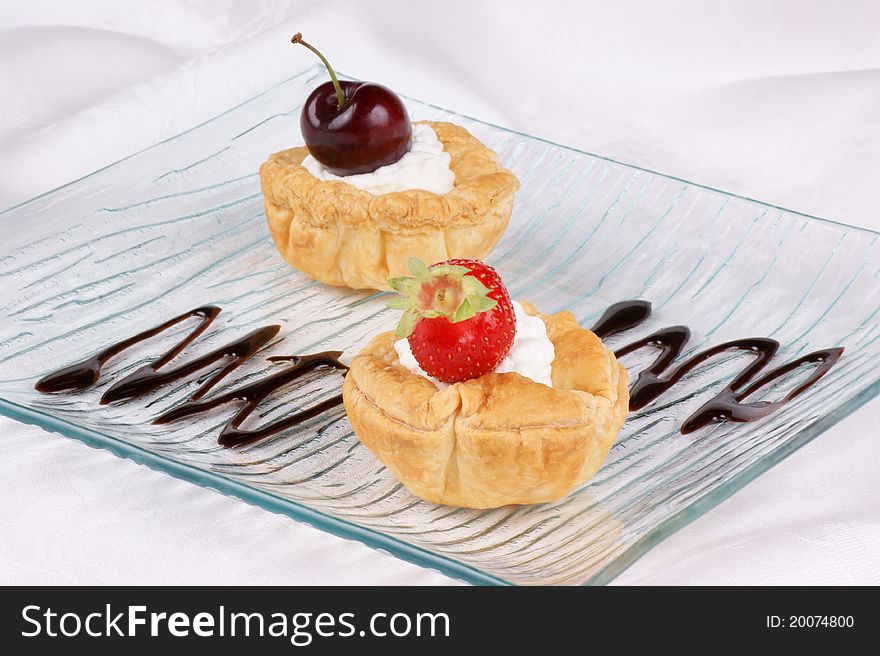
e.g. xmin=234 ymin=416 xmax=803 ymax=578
xmin=394 ymin=301 xmax=556 ymax=389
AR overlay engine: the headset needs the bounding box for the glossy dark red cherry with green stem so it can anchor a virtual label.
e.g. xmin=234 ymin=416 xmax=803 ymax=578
xmin=291 ymin=33 xmax=412 ymax=175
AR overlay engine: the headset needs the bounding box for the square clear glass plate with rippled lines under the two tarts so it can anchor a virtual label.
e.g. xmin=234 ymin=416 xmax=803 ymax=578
xmin=0 ymin=68 xmax=880 ymax=584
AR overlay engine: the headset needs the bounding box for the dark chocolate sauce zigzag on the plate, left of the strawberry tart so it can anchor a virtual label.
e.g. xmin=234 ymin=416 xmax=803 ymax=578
xmin=35 ymin=305 xmax=348 ymax=446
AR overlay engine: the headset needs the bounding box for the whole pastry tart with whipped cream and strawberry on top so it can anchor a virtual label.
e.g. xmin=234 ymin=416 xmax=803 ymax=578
xmin=343 ymin=258 xmax=629 ymax=508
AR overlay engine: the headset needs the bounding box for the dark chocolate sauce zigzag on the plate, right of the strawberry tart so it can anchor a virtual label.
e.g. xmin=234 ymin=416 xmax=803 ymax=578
xmin=592 ymin=300 xmax=843 ymax=434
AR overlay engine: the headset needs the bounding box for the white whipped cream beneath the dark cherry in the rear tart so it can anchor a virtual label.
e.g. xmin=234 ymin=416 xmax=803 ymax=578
xmin=302 ymin=123 xmax=455 ymax=196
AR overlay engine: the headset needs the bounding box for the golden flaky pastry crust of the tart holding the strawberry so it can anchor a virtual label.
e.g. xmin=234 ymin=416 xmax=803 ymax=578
xmin=343 ymin=303 xmax=629 ymax=508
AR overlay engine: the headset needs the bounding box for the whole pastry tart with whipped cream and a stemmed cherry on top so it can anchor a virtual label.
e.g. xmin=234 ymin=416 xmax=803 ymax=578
xmin=260 ymin=34 xmax=519 ymax=289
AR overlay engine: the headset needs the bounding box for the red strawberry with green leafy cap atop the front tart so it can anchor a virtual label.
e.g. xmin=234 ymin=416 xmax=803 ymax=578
xmin=388 ymin=257 xmax=516 ymax=383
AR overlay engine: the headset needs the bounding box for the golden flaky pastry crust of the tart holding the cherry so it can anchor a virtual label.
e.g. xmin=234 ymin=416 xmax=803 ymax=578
xmin=260 ymin=121 xmax=519 ymax=289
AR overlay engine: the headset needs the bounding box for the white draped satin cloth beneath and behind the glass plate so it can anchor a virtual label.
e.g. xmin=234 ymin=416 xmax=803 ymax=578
xmin=0 ymin=0 xmax=880 ymax=584
